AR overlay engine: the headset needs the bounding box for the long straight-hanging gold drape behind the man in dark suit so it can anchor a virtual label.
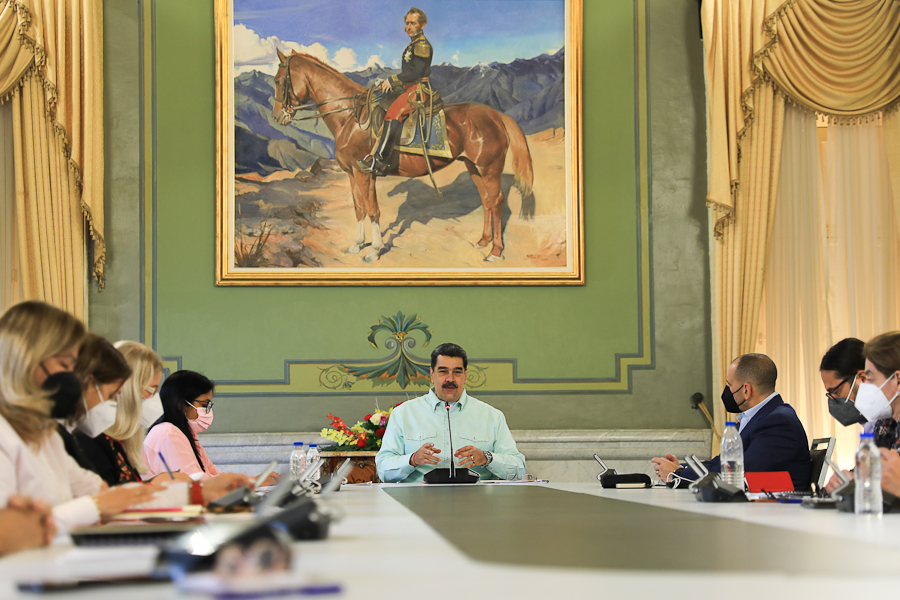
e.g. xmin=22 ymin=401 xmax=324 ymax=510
xmin=702 ymin=0 xmax=784 ymax=432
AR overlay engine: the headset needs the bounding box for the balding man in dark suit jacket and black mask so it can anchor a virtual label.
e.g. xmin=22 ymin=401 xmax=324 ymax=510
xmin=652 ymin=354 xmax=812 ymax=490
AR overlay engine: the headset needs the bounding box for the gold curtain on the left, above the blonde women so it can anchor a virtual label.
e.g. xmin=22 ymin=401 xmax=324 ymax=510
xmin=0 ymin=0 xmax=106 ymax=317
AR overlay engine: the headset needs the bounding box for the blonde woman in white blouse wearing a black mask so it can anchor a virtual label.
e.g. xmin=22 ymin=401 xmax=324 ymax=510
xmin=0 ymin=301 xmax=155 ymax=533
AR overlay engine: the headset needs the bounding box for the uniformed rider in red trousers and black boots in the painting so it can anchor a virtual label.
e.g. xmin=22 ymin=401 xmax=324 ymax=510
xmin=357 ymin=8 xmax=434 ymax=176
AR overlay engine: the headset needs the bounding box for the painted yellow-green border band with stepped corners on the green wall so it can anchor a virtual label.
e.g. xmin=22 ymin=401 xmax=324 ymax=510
xmin=141 ymin=0 xmax=656 ymax=399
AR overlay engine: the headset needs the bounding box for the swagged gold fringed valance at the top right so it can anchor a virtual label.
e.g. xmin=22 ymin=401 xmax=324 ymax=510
xmin=702 ymin=0 xmax=900 ymax=238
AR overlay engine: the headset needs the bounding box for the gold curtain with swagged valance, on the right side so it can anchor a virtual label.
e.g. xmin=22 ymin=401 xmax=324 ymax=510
xmin=701 ymin=0 xmax=900 ymax=432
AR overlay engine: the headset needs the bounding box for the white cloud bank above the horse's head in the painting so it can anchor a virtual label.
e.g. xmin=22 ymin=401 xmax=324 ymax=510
xmin=233 ymin=25 xmax=384 ymax=76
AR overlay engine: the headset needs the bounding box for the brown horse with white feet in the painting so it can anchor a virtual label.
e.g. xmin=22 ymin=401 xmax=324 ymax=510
xmin=272 ymin=50 xmax=534 ymax=262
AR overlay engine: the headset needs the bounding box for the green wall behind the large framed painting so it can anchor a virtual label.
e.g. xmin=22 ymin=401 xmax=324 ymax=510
xmin=90 ymin=0 xmax=710 ymax=432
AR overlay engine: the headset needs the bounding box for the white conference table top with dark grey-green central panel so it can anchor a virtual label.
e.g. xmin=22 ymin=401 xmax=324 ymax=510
xmin=0 ymin=484 xmax=900 ymax=600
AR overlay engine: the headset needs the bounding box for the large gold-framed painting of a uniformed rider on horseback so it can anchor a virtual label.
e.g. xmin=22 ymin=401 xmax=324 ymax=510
xmin=216 ymin=0 xmax=584 ymax=286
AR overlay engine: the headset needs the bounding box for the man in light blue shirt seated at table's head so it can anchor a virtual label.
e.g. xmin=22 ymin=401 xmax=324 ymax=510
xmin=375 ymin=344 xmax=525 ymax=483
